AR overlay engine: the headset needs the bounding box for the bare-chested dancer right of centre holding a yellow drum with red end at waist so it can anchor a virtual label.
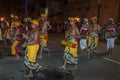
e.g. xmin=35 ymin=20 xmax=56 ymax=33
xmin=61 ymin=18 xmax=80 ymax=69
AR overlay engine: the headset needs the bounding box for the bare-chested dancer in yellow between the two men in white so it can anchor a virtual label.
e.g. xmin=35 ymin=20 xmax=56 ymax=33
xmin=88 ymin=17 xmax=100 ymax=59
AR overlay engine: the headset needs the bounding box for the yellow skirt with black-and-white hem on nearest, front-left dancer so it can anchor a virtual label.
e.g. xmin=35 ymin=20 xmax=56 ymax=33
xmin=24 ymin=39 xmax=39 ymax=70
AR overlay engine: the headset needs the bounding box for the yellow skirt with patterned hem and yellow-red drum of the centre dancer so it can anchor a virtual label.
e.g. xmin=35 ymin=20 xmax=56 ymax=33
xmin=62 ymin=38 xmax=78 ymax=64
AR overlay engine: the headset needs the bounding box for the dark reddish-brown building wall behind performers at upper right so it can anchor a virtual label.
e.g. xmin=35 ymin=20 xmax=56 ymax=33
xmin=48 ymin=0 xmax=120 ymax=25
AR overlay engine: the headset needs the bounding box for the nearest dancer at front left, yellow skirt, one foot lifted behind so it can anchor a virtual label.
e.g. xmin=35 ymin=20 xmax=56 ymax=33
xmin=24 ymin=21 xmax=42 ymax=77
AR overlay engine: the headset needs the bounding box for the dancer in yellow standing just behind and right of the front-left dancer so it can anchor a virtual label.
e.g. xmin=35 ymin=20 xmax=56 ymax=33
xmin=40 ymin=14 xmax=52 ymax=58
